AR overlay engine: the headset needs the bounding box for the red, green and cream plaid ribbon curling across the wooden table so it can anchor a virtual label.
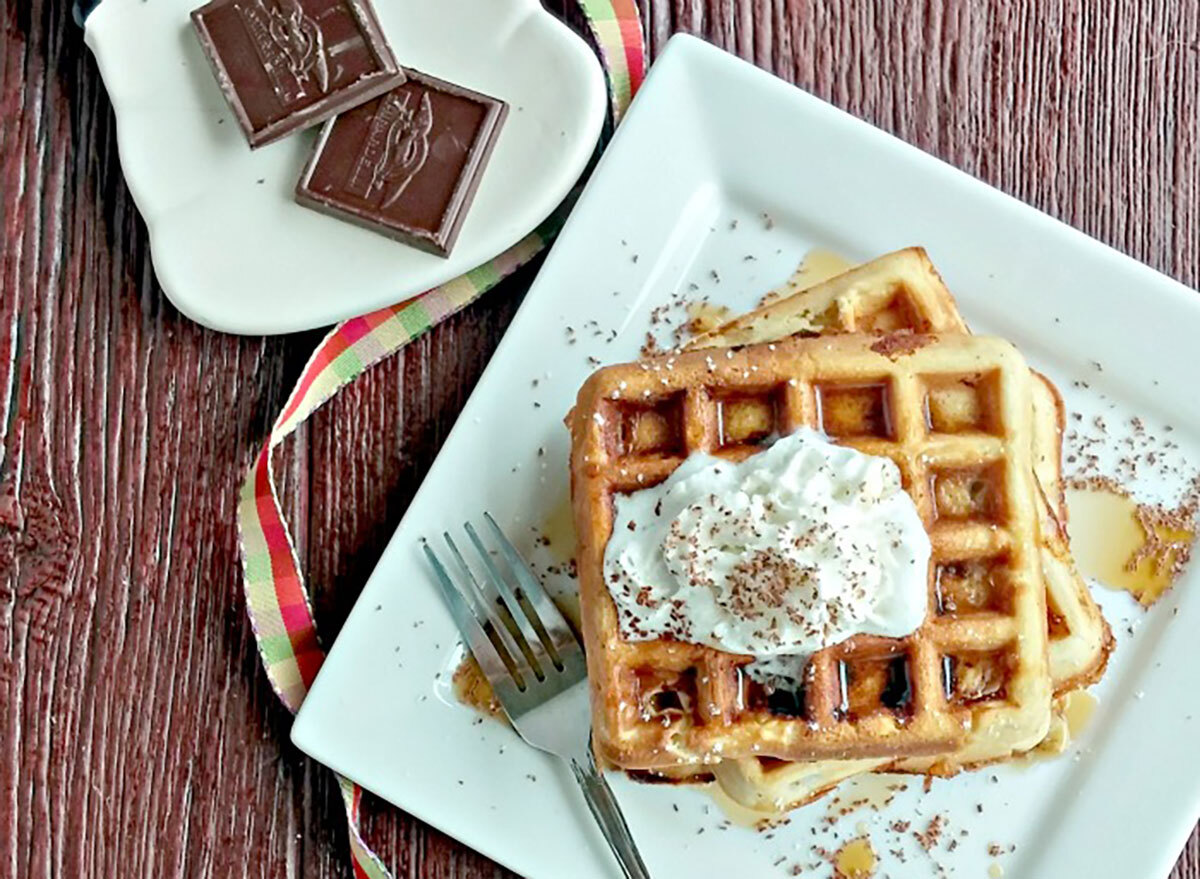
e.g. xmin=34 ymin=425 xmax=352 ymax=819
xmin=238 ymin=0 xmax=646 ymax=879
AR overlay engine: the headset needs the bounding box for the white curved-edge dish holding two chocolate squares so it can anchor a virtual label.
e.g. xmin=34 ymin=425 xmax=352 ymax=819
xmin=86 ymin=0 xmax=606 ymax=334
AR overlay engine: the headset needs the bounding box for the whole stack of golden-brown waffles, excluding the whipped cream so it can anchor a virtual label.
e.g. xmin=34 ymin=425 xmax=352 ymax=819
xmin=569 ymin=249 xmax=1112 ymax=812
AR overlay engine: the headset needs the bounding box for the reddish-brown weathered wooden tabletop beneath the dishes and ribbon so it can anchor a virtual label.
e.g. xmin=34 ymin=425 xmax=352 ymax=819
xmin=0 ymin=0 xmax=1200 ymax=879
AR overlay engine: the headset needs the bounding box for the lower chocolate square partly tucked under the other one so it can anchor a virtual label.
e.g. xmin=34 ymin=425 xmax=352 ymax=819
xmin=296 ymin=71 xmax=509 ymax=256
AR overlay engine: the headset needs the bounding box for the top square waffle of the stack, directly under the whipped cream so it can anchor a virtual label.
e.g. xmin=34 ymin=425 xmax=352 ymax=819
xmin=569 ymin=333 xmax=1051 ymax=770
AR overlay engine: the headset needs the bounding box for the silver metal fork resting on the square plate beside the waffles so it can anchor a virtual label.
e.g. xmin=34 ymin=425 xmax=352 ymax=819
xmin=421 ymin=513 xmax=650 ymax=879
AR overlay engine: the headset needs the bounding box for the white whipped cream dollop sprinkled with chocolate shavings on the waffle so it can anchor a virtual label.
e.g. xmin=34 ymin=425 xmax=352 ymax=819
xmin=604 ymin=427 xmax=930 ymax=677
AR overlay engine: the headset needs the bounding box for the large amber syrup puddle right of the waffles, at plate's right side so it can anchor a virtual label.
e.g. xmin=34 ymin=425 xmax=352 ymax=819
xmin=1067 ymin=485 xmax=1196 ymax=608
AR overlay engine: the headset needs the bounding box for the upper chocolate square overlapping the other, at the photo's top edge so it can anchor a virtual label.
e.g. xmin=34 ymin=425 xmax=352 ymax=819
xmin=192 ymin=0 xmax=404 ymax=147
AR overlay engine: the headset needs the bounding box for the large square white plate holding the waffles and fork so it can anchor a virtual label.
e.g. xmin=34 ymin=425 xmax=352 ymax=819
xmin=293 ymin=37 xmax=1200 ymax=879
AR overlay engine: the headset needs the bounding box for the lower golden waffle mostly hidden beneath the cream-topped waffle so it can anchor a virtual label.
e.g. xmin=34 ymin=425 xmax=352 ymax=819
xmin=689 ymin=247 xmax=1112 ymax=811
